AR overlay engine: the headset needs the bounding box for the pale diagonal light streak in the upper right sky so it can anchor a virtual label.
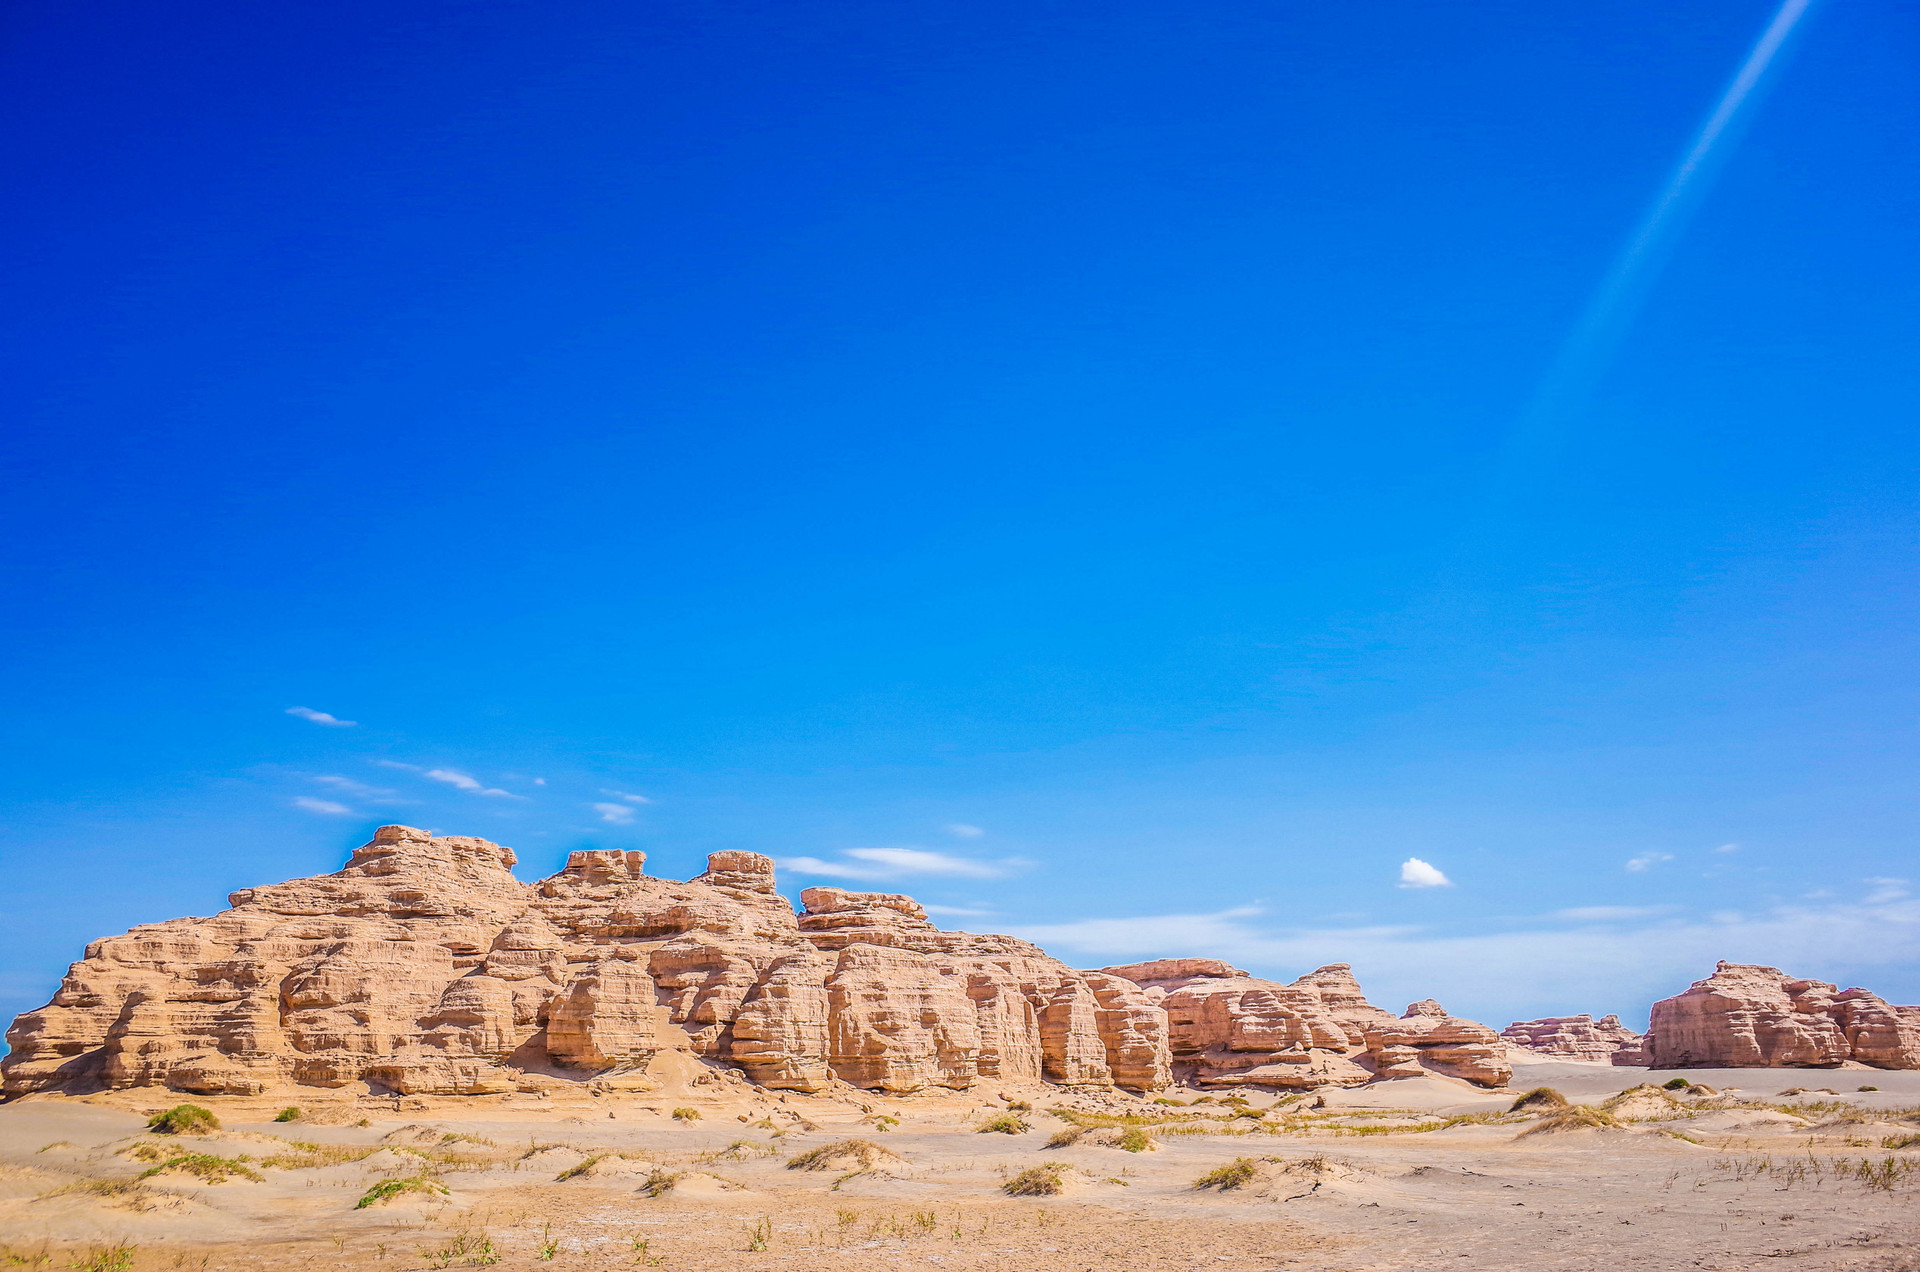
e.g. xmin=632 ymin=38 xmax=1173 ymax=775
xmin=1509 ymin=0 xmax=1814 ymax=459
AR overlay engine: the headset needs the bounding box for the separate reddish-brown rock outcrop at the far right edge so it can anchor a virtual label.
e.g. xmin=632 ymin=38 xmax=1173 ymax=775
xmin=1647 ymin=963 xmax=1920 ymax=1068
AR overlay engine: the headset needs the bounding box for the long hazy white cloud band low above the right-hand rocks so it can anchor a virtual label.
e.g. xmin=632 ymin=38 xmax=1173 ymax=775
xmin=1012 ymin=899 xmax=1920 ymax=1028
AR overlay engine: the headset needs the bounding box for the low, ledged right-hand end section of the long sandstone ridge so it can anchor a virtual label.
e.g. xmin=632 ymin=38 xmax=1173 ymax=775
xmin=1102 ymin=959 xmax=1513 ymax=1088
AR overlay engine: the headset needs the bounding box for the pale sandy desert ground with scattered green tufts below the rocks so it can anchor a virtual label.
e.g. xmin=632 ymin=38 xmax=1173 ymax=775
xmin=0 ymin=1063 xmax=1920 ymax=1272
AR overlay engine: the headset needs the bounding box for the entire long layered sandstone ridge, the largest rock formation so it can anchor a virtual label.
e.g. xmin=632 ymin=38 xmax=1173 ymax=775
xmin=0 ymin=826 xmax=1511 ymax=1097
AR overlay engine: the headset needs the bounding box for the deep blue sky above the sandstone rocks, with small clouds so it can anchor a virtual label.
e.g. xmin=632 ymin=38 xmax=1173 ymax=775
xmin=0 ymin=0 xmax=1920 ymax=1024
